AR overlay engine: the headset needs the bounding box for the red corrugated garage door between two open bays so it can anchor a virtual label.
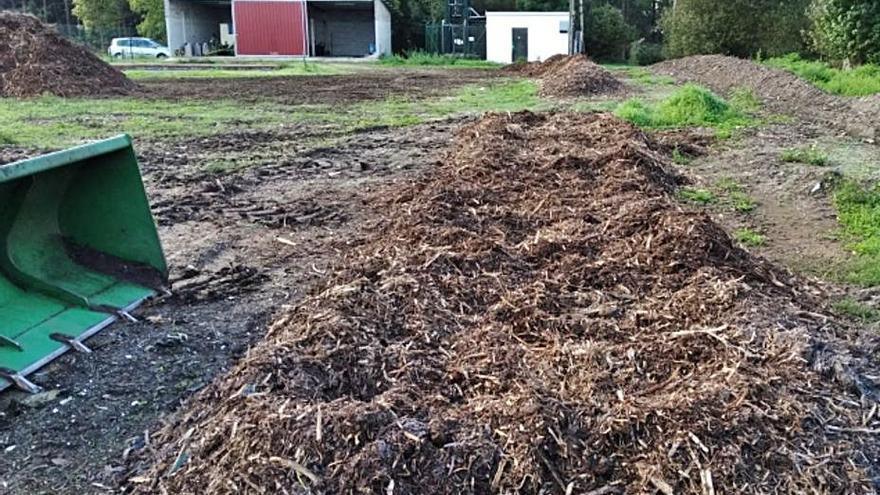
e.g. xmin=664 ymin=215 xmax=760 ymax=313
xmin=232 ymin=0 xmax=307 ymax=55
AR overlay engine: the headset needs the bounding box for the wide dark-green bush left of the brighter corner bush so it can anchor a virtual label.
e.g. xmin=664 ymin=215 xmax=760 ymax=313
xmin=661 ymin=0 xmax=810 ymax=57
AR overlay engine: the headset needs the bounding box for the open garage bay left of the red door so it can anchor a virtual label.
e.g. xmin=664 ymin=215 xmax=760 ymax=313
xmin=165 ymin=0 xmax=232 ymax=52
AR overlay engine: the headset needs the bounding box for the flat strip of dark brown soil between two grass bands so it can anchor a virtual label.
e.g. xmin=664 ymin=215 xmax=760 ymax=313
xmin=141 ymin=69 xmax=496 ymax=105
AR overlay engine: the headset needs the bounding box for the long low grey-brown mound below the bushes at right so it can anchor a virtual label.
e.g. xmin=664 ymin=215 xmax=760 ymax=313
xmin=651 ymin=55 xmax=880 ymax=138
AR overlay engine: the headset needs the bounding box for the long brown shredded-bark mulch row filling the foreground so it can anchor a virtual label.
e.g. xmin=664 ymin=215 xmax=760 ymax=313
xmin=129 ymin=113 xmax=880 ymax=495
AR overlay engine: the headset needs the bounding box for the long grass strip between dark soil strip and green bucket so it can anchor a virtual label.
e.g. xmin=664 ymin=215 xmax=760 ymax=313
xmin=0 ymin=79 xmax=547 ymax=149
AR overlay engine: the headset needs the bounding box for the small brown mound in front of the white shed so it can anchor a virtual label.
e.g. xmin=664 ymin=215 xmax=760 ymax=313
xmin=541 ymin=55 xmax=623 ymax=97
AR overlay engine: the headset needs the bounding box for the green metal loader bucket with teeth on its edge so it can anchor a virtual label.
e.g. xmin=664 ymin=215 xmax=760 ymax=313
xmin=0 ymin=135 xmax=168 ymax=392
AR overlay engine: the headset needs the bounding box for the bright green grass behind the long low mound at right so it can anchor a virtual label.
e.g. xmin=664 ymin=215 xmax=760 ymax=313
xmin=764 ymin=53 xmax=880 ymax=96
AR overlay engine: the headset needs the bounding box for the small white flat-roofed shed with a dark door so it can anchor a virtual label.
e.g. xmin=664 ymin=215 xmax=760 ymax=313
xmin=486 ymin=12 xmax=569 ymax=64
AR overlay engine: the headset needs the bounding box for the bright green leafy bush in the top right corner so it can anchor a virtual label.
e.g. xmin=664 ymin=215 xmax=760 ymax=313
xmin=810 ymin=0 xmax=880 ymax=64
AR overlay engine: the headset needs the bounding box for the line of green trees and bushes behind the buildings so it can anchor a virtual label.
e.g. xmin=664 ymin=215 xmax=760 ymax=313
xmin=0 ymin=0 xmax=880 ymax=65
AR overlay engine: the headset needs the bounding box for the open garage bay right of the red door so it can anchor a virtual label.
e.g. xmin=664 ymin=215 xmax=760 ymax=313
xmin=309 ymin=2 xmax=376 ymax=57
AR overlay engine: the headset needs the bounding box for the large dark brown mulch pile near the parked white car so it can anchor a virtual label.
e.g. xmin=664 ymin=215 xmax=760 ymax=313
xmin=0 ymin=12 xmax=136 ymax=97
